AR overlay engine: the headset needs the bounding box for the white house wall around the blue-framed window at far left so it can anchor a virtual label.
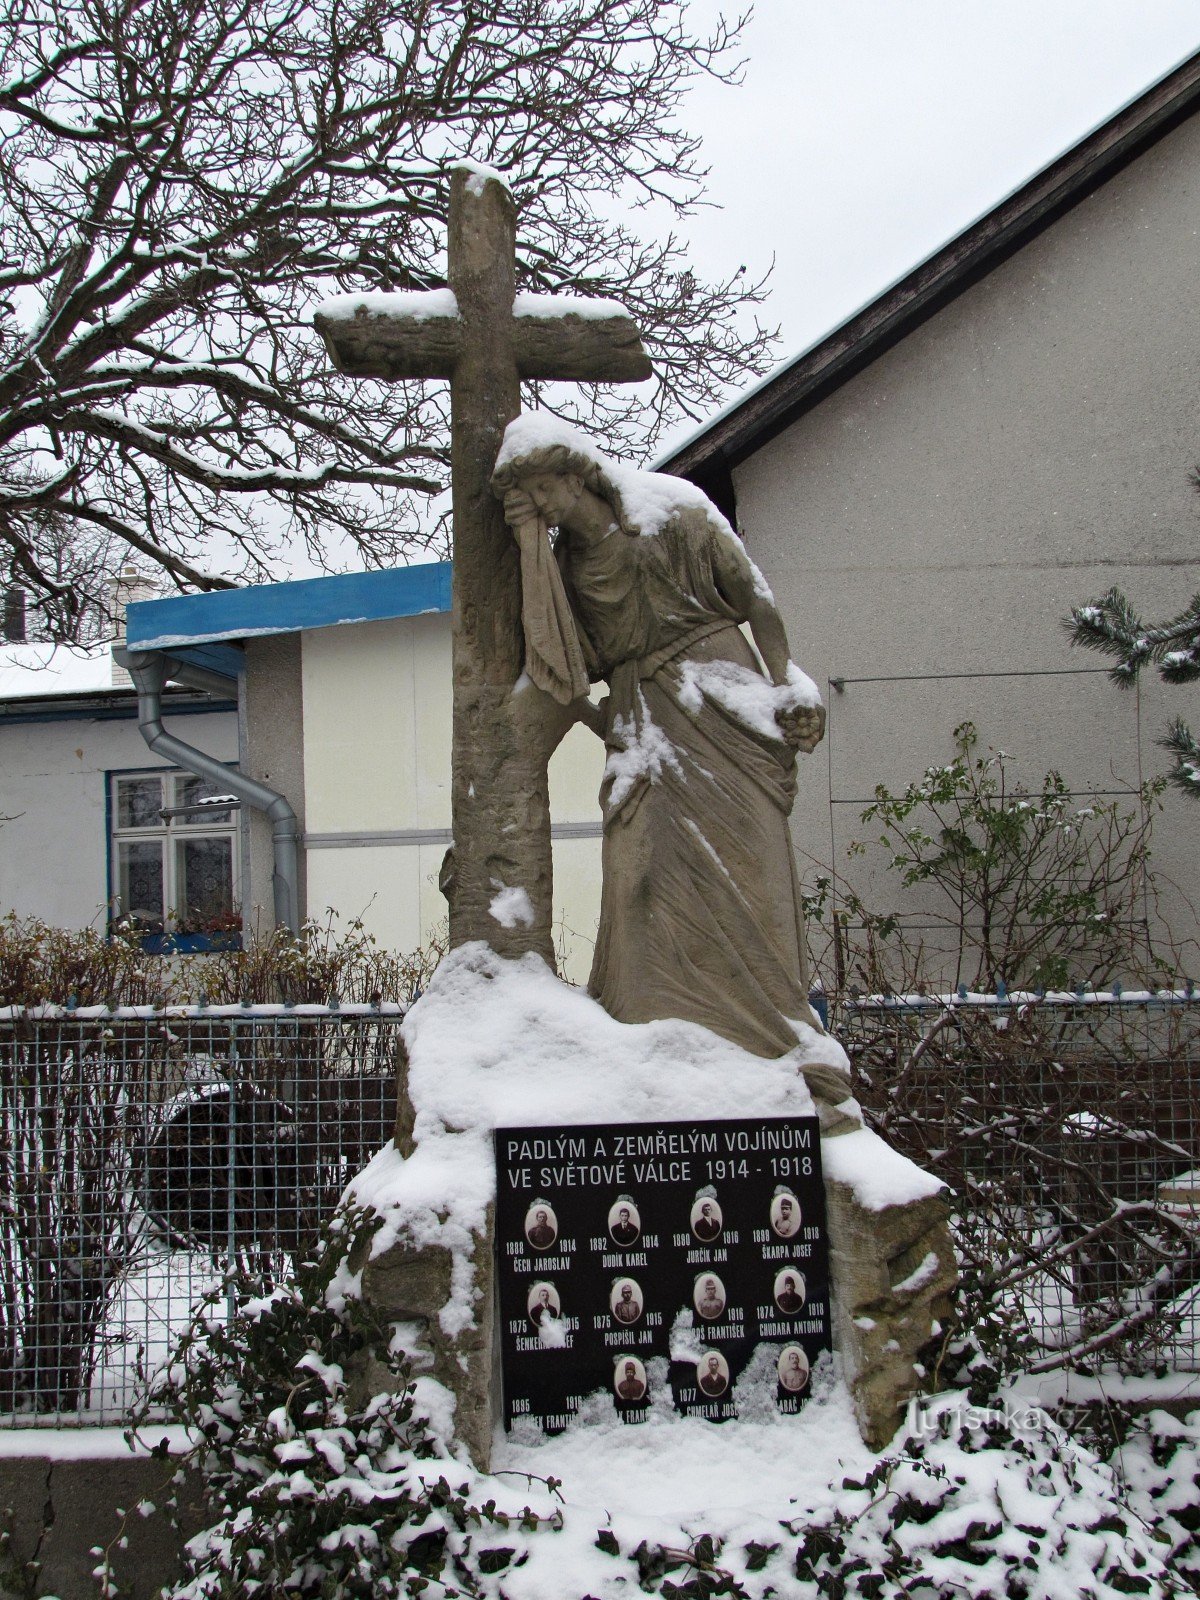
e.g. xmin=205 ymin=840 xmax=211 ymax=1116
xmin=0 ymin=710 xmax=237 ymax=928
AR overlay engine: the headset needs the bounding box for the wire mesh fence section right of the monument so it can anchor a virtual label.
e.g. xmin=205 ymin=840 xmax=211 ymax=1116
xmin=842 ymin=989 xmax=1200 ymax=1373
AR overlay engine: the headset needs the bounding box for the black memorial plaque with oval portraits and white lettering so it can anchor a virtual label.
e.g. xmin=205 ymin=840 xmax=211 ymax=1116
xmin=496 ymin=1117 xmax=830 ymax=1430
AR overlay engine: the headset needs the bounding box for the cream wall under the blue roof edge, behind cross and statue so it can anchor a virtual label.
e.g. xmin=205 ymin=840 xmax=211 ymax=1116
xmin=302 ymin=613 xmax=603 ymax=982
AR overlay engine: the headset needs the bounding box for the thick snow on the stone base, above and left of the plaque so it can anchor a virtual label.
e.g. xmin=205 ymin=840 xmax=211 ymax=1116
xmin=334 ymin=944 xmax=835 ymax=1338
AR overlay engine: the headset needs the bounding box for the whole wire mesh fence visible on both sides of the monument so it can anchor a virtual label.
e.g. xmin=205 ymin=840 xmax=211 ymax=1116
xmin=0 ymin=990 xmax=1200 ymax=1426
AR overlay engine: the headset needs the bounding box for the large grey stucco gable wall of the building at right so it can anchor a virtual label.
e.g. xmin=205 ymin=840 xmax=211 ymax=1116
xmin=734 ymin=117 xmax=1200 ymax=968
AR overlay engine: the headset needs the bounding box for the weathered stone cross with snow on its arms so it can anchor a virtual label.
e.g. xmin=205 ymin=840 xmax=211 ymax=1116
xmin=315 ymin=166 xmax=651 ymax=965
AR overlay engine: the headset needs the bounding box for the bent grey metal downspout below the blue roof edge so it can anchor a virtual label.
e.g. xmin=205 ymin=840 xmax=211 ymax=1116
xmin=114 ymin=650 xmax=301 ymax=933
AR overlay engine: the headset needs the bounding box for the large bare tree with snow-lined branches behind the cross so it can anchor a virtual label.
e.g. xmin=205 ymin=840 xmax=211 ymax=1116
xmin=0 ymin=0 xmax=770 ymax=637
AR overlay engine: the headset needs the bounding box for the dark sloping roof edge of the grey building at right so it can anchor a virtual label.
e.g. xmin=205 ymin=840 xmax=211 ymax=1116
xmin=656 ymin=51 xmax=1200 ymax=518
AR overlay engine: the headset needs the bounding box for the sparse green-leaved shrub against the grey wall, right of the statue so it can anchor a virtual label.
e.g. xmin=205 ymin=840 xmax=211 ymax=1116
xmin=805 ymin=722 xmax=1171 ymax=1008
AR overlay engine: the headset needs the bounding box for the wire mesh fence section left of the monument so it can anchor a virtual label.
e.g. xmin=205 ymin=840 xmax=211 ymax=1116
xmin=0 ymin=1006 xmax=402 ymax=1427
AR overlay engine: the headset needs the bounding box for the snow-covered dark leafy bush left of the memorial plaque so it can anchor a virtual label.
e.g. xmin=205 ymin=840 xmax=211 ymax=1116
xmin=115 ymin=1211 xmax=566 ymax=1600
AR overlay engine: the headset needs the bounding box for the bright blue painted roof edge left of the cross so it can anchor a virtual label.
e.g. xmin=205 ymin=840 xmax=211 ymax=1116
xmin=125 ymin=562 xmax=451 ymax=650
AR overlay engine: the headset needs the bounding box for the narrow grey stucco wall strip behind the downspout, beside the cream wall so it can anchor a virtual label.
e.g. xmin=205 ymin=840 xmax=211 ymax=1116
xmin=242 ymin=634 xmax=307 ymax=934
